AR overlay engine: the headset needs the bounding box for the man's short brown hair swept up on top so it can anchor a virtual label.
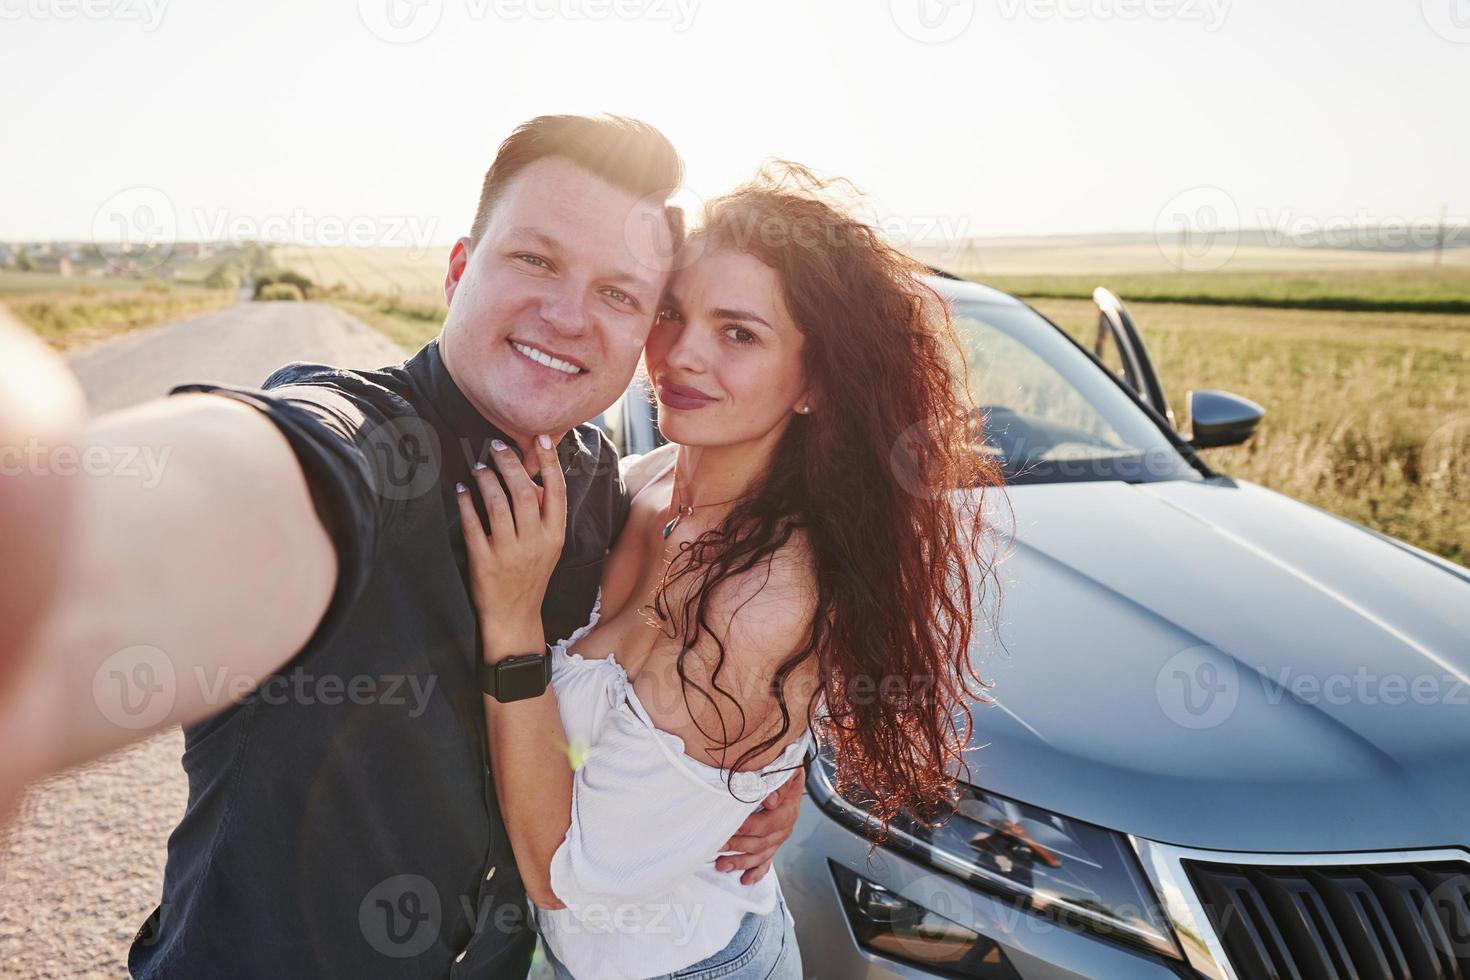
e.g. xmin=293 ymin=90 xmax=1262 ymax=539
xmin=469 ymin=115 xmax=684 ymax=245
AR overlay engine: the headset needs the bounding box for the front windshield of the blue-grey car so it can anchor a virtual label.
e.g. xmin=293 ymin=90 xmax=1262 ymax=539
xmin=953 ymin=300 xmax=1202 ymax=483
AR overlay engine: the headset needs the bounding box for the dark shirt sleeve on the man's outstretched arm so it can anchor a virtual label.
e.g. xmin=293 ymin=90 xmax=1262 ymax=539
xmin=169 ymin=363 xmax=412 ymax=649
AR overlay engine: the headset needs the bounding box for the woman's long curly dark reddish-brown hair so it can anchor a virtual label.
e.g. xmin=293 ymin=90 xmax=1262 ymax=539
xmin=653 ymin=162 xmax=1003 ymax=837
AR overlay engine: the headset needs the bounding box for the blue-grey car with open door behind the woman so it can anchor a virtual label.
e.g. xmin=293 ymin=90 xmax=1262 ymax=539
xmin=606 ymin=276 xmax=1470 ymax=980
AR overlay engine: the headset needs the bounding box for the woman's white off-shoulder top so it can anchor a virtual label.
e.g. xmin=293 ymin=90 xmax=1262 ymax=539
xmin=535 ymin=461 xmax=811 ymax=979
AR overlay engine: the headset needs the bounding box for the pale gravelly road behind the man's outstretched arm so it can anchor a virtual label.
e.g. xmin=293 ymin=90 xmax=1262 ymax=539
xmin=0 ymin=303 xmax=404 ymax=980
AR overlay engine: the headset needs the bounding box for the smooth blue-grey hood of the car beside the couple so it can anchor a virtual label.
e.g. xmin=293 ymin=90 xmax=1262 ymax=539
xmin=969 ymin=478 xmax=1470 ymax=851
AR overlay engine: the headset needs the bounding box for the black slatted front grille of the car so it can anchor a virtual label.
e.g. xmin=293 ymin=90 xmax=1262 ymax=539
xmin=1183 ymin=860 xmax=1470 ymax=980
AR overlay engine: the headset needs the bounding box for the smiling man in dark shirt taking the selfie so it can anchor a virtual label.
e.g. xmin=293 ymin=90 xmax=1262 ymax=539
xmin=4 ymin=116 xmax=800 ymax=980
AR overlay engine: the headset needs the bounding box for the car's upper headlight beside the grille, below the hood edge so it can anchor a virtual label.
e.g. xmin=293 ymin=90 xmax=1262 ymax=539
xmin=809 ymin=752 xmax=1182 ymax=959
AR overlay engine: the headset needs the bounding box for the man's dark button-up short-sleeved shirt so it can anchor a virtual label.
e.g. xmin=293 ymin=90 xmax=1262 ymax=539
xmin=128 ymin=341 xmax=628 ymax=980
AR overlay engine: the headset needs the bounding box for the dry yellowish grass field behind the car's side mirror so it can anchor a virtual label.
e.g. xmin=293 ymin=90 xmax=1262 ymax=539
xmin=1030 ymin=300 xmax=1470 ymax=564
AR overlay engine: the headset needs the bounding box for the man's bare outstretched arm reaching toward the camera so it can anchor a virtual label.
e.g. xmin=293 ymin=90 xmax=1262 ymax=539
xmin=0 ymin=348 xmax=337 ymax=807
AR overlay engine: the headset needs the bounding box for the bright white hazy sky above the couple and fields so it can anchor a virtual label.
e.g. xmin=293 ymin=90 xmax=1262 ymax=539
xmin=0 ymin=0 xmax=1470 ymax=244
